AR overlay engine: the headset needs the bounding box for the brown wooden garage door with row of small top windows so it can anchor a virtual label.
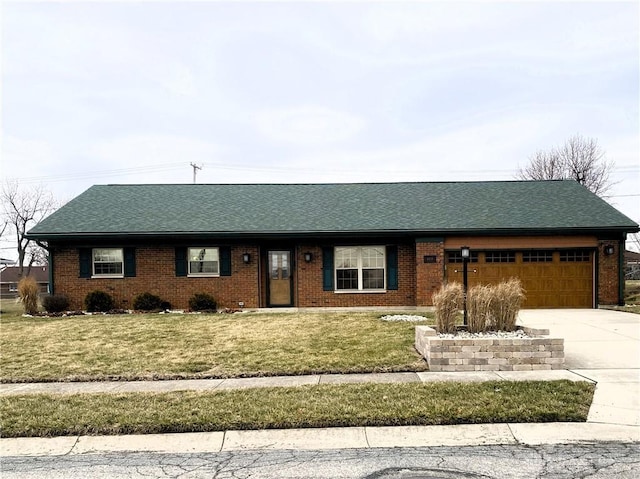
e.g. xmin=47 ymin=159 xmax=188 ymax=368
xmin=446 ymin=250 xmax=594 ymax=308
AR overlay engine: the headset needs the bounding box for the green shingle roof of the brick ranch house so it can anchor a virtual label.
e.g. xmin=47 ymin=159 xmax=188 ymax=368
xmin=29 ymin=181 xmax=638 ymax=239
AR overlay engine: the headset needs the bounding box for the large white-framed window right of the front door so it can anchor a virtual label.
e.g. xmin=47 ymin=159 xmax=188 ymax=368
xmin=335 ymin=246 xmax=386 ymax=291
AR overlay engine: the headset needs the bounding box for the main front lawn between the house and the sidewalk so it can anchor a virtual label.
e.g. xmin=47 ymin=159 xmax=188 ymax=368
xmin=0 ymin=302 xmax=427 ymax=382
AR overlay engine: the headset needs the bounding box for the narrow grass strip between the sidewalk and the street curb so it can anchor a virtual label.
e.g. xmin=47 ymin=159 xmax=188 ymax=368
xmin=0 ymin=381 xmax=594 ymax=437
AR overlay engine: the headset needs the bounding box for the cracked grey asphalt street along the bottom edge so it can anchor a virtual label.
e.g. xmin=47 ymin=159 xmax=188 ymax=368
xmin=1 ymin=442 xmax=640 ymax=479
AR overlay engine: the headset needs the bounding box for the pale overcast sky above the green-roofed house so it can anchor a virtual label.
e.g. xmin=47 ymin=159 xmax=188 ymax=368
xmin=0 ymin=0 xmax=640 ymax=257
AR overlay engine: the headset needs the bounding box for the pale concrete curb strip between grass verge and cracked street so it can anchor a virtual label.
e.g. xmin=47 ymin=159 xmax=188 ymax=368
xmin=0 ymin=422 xmax=640 ymax=457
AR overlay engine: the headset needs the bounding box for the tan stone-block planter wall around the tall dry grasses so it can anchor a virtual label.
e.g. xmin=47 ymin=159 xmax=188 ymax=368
xmin=415 ymin=326 xmax=564 ymax=371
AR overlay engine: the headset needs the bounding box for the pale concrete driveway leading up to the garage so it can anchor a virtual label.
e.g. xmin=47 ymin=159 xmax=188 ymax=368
xmin=519 ymin=309 xmax=640 ymax=426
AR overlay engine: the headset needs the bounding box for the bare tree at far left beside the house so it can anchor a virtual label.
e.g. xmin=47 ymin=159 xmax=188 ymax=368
xmin=0 ymin=181 xmax=55 ymax=277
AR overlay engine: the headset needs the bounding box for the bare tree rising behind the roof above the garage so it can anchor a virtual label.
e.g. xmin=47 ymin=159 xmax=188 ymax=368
xmin=516 ymin=134 xmax=614 ymax=196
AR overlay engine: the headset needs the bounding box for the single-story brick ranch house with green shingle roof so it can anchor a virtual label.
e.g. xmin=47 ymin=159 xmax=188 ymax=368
xmin=28 ymin=181 xmax=638 ymax=308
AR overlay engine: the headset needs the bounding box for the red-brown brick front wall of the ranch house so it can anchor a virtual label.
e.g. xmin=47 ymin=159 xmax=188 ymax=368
xmin=53 ymin=238 xmax=620 ymax=309
